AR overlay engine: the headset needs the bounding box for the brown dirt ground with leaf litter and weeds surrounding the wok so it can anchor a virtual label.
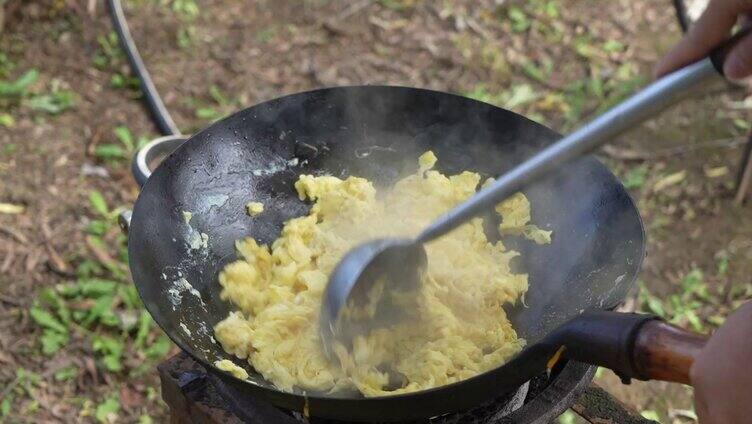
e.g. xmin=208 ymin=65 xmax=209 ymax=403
xmin=0 ymin=0 xmax=752 ymax=423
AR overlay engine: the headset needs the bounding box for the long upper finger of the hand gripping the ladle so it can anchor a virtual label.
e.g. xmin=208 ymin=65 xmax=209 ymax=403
xmin=655 ymin=0 xmax=752 ymax=76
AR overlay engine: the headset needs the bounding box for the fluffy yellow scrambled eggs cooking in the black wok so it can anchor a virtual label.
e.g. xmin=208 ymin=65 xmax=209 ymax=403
xmin=215 ymin=152 xmax=551 ymax=396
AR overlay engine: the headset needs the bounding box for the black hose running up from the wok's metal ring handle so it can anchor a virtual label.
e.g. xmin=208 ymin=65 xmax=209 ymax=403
xmin=107 ymin=0 xmax=180 ymax=135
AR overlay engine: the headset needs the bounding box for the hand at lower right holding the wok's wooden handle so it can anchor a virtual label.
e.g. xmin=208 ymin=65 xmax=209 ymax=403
xmin=690 ymin=302 xmax=752 ymax=424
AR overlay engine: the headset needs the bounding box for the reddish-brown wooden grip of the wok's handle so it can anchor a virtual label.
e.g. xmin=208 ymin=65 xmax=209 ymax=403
xmin=632 ymin=320 xmax=708 ymax=384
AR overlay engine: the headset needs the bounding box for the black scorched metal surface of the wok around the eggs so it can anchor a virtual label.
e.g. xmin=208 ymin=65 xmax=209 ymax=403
xmin=129 ymin=87 xmax=644 ymax=419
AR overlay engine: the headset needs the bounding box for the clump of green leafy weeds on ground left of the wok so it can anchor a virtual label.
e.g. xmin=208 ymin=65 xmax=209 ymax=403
xmin=29 ymin=191 xmax=171 ymax=380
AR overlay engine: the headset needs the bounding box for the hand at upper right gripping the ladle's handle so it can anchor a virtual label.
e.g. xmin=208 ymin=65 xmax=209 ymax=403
xmin=655 ymin=0 xmax=752 ymax=80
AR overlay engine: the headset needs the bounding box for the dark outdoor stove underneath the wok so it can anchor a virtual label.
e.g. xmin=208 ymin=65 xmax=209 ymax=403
xmin=158 ymin=352 xmax=654 ymax=424
